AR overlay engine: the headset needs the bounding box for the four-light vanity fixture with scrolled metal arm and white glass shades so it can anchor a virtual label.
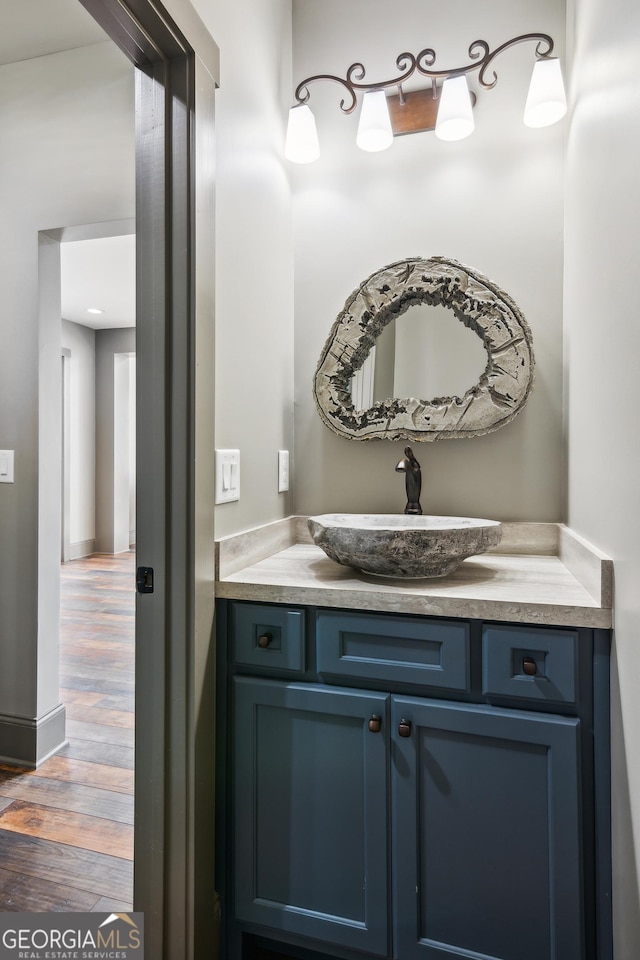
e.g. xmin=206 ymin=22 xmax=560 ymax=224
xmin=285 ymin=33 xmax=567 ymax=163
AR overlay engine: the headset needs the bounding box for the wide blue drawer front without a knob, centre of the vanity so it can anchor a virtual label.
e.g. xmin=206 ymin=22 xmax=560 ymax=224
xmin=317 ymin=611 xmax=469 ymax=690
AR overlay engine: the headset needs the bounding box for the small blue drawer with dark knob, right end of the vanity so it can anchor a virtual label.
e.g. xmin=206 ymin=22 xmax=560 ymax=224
xmin=482 ymin=626 xmax=578 ymax=704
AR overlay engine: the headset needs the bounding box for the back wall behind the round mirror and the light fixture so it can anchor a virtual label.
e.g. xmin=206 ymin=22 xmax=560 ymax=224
xmin=291 ymin=0 xmax=565 ymax=520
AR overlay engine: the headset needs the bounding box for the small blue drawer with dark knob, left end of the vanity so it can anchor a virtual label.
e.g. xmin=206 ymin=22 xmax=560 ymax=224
xmin=231 ymin=603 xmax=305 ymax=673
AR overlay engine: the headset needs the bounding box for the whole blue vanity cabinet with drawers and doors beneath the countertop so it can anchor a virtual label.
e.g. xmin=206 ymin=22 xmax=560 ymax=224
xmin=216 ymin=601 xmax=612 ymax=960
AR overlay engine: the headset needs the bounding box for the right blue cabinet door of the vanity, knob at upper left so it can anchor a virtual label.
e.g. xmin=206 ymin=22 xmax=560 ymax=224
xmin=392 ymin=697 xmax=584 ymax=960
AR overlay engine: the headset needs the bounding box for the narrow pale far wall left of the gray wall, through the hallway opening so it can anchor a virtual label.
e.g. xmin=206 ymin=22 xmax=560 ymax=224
xmin=62 ymin=319 xmax=96 ymax=546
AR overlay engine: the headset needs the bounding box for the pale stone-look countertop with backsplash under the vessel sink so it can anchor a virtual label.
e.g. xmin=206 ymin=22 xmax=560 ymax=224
xmin=216 ymin=518 xmax=613 ymax=629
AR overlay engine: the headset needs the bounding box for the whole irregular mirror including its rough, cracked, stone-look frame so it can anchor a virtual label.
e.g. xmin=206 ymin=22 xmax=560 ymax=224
xmin=313 ymin=257 xmax=534 ymax=440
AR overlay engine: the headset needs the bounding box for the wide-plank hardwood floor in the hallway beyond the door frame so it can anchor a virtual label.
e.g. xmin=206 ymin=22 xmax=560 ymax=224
xmin=0 ymin=553 xmax=135 ymax=912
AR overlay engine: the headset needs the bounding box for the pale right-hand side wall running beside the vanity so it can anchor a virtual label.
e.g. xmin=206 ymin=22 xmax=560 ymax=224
xmin=565 ymin=0 xmax=640 ymax=960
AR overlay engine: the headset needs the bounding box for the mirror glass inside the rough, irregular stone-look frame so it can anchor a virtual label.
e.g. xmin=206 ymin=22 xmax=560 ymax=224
xmin=351 ymin=303 xmax=487 ymax=411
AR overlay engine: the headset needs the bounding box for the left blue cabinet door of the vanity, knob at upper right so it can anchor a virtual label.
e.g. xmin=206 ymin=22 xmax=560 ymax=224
xmin=234 ymin=677 xmax=389 ymax=955
